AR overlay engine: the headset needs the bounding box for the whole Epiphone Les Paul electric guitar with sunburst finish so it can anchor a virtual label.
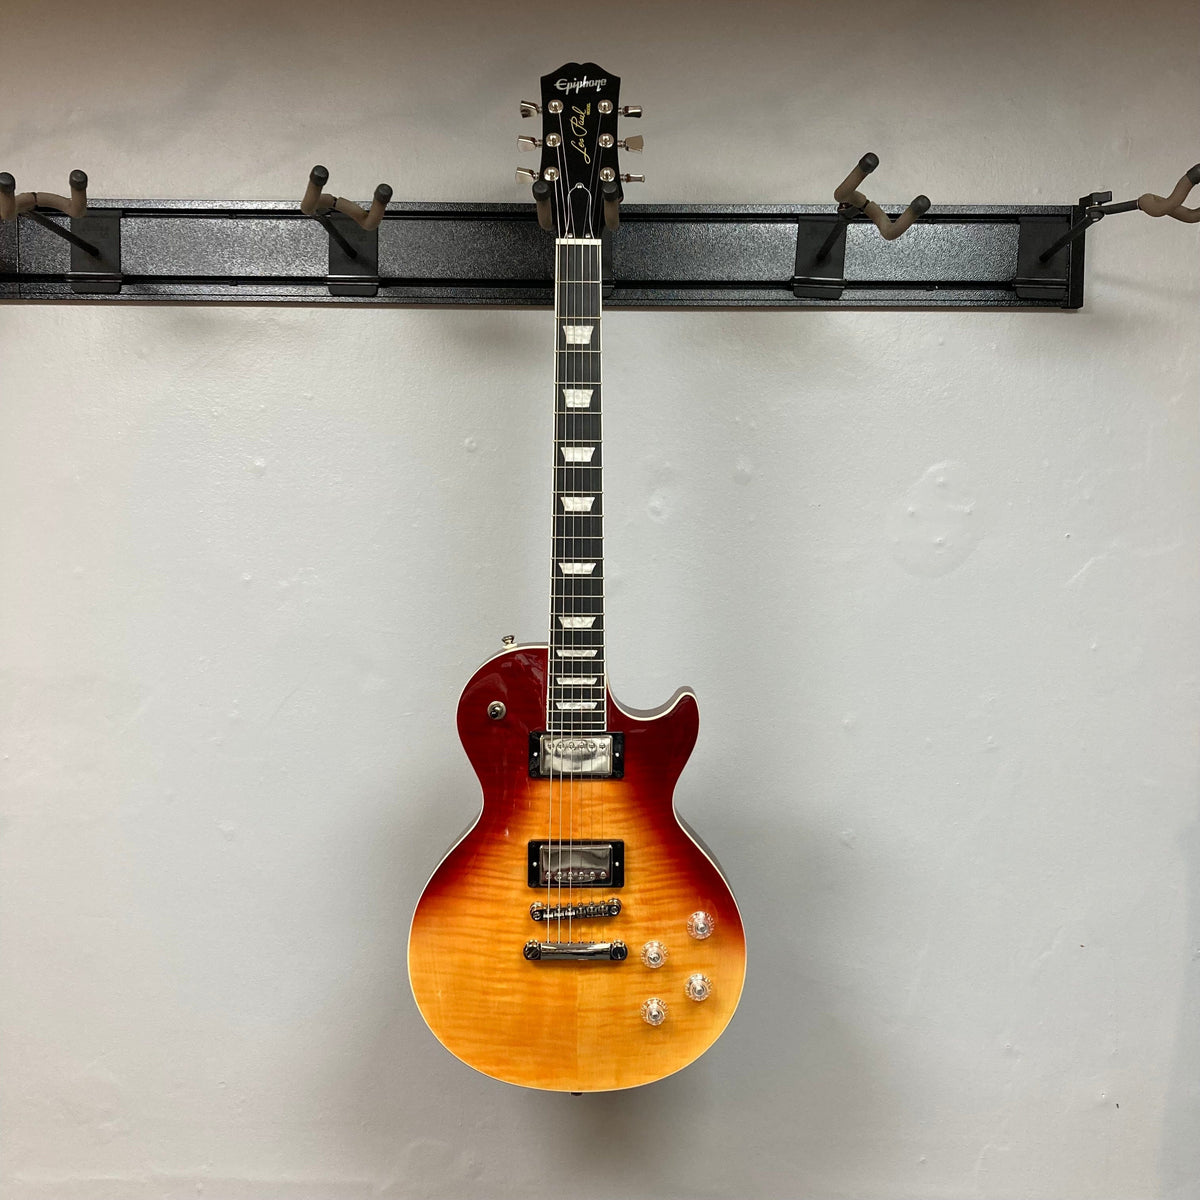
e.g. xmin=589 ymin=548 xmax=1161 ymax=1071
xmin=408 ymin=62 xmax=745 ymax=1092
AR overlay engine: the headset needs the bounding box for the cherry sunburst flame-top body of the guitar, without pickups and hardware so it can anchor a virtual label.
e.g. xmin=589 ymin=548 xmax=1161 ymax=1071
xmin=408 ymin=647 xmax=745 ymax=1092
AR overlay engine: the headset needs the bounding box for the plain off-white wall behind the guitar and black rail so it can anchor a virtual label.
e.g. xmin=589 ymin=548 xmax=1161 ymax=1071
xmin=0 ymin=0 xmax=1200 ymax=1200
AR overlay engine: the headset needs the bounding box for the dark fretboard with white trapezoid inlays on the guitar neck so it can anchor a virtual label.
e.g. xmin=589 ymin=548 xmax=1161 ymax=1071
xmin=546 ymin=238 xmax=605 ymax=733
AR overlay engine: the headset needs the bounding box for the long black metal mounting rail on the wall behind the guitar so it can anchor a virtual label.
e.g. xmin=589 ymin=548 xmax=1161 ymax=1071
xmin=0 ymin=200 xmax=1085 ymax=310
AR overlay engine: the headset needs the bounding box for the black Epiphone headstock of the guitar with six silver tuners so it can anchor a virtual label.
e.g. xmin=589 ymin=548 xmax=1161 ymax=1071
xmin=517 ymin=62 xmax=644 ymax=238
